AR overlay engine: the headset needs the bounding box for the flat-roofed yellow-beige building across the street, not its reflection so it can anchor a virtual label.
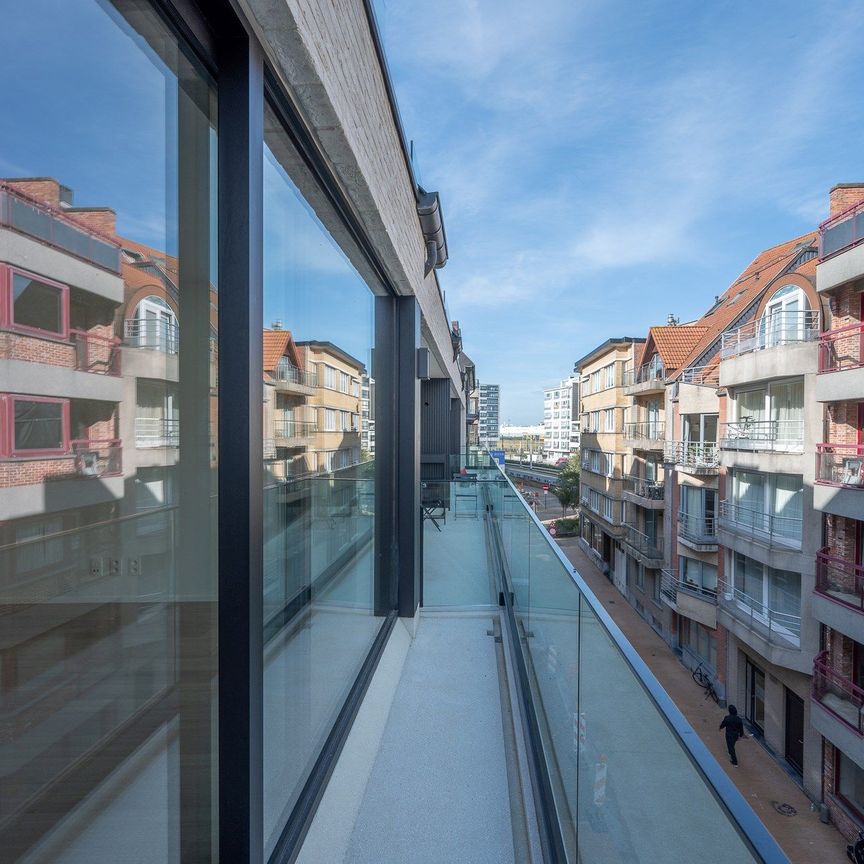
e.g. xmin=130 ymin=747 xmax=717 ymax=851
xmin=575 ymin=336 xmax=645 ymax=580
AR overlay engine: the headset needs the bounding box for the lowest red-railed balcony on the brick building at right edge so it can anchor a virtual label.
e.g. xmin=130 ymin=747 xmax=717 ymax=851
xmin=810 ymin=651 xmax=864 ymax=764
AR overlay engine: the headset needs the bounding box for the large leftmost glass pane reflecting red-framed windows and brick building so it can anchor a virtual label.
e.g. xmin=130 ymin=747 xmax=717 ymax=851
xmin=0 ymin=0 xmax=218 ymax=864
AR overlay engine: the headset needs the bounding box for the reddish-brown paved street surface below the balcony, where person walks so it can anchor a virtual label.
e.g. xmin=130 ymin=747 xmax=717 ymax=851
xmin=558 ymin=537 xmax=847 ymax=864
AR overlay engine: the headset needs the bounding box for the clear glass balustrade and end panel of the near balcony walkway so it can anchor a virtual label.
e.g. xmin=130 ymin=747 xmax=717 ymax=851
xmin=420 ymin=456 xmax=785 ymax=862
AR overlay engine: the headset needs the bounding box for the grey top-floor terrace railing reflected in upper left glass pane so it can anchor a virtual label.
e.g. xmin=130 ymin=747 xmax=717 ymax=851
xmin=0 ymin=184 xmax=120 ymax=273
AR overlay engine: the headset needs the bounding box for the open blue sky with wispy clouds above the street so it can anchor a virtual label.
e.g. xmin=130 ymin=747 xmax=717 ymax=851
xmin=376 ymin=0 xmax=864 ymax=423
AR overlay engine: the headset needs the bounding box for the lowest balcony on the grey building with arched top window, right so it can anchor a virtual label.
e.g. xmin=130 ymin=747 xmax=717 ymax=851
xmin=718 ymin=582 xmax=810 ymax=672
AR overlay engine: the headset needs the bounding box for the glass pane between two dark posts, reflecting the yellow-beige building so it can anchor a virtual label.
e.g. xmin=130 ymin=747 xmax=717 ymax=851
xmin=262 ymin=103 xmax=380 ymax=855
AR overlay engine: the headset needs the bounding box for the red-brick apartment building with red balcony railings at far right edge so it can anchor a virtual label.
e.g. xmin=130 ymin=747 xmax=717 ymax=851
xmin=808 ymin=183 xmax=864 ymax=839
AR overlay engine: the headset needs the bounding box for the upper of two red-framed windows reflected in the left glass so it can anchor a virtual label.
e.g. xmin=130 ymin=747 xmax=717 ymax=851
xmin=0 ymin=264 xmax=69 ymax=341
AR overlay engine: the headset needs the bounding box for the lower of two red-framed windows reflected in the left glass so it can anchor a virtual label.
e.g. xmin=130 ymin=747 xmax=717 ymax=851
xmin=0 ymin=394 xmax=71 ymax=458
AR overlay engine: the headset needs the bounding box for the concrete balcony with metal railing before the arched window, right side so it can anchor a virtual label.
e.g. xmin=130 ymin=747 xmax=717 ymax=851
xmin=720 ymin=310 xmax=821 ymax=387
